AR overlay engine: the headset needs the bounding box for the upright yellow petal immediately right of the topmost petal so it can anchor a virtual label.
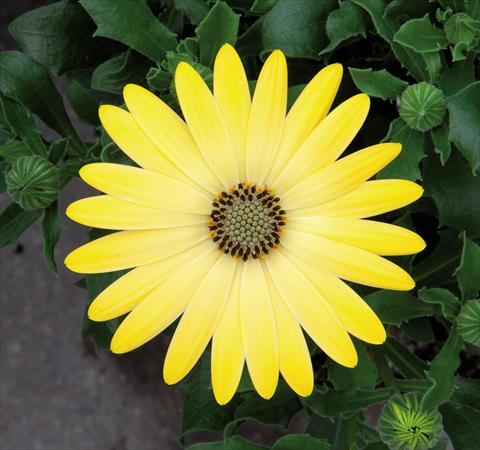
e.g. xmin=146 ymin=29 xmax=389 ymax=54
xmin=246 ymin=50 xmax=288 ymax=184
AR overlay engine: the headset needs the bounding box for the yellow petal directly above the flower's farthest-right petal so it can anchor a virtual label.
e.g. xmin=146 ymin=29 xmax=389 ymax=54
xmin=295 ymin=180 xmax=423 ymax=219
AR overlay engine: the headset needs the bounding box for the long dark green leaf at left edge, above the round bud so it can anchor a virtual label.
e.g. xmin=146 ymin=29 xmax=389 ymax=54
xmin=0 ymin=52 xmax=84 ymax=154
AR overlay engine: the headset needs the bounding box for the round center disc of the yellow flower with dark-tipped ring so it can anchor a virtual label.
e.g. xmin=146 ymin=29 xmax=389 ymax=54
xmin=209 ymin=183 xmax=286 ymax=261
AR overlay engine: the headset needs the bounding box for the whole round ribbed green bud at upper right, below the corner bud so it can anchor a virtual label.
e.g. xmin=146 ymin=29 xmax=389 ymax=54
xmin=399 ymin=81 xmax=447 ymax=131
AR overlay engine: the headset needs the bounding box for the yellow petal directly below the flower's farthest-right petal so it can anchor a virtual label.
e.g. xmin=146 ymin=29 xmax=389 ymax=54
xmin=282 ymin=230 xmax=415 ymax=291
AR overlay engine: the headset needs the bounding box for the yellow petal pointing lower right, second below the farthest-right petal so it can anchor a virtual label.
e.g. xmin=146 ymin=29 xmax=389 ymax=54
xmin=282 ymin=249 xmax=386 ymax=344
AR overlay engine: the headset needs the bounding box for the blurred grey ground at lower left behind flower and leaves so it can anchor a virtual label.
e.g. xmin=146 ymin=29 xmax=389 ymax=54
xmin=0 ymin=0 xmax=186 ymax=450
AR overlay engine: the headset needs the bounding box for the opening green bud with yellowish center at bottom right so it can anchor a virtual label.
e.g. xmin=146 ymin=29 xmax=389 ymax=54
xmin=379 ymin=392 xmax=443 ymax=450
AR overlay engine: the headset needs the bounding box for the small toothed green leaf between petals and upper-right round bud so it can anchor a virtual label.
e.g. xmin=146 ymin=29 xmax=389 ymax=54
xmin=348 ymin=67 xmax=408 ymax=100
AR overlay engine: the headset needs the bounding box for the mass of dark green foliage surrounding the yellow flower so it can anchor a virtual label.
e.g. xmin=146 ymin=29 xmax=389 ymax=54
xmin=0 ymin=0 xmax=480 ymax=450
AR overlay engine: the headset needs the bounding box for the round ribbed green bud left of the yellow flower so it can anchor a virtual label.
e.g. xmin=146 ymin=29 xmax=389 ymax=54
xmin=5 ymin=155 xmax=60 ymax=210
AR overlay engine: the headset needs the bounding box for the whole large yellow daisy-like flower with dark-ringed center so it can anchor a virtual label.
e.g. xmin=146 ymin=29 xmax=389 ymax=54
xmin=65 ymin=45 xmax=425 ymax=404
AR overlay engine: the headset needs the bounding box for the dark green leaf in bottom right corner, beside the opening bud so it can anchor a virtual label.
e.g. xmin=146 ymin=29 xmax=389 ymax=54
xmin=440 ymin=403 xmax=480 ymax=450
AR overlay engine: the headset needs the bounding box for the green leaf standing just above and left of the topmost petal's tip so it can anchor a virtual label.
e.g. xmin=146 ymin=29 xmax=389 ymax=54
xmin=197 ymin=1 xmax=240 ymax=67
